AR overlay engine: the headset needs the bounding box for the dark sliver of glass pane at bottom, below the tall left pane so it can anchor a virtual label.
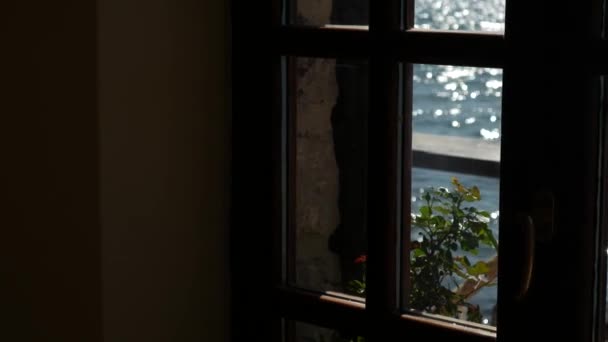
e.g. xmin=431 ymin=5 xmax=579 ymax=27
xmin=284 ymin=321 xmax=365 ymax=342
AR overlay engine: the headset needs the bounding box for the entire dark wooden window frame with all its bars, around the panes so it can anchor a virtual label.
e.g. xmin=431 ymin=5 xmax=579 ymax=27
xmin=231 ymin=0 xmax=608 ymax=341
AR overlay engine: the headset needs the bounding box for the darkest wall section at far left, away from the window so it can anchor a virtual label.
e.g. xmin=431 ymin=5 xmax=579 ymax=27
xmin=0 ymin=0 xmax=102 ymax=342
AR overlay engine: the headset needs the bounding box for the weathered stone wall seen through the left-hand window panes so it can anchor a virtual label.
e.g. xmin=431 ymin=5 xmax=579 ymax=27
xmin=291 ymin=0 xmax=368 ymax=341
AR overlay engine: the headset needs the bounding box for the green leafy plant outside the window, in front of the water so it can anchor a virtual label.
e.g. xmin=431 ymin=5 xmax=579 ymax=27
xmin=349 ymin=178 xmax=498 ymax=322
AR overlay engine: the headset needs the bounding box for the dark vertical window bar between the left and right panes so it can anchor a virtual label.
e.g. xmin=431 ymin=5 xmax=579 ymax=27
xmin=366 ymin=0 xmax=401 ymax=341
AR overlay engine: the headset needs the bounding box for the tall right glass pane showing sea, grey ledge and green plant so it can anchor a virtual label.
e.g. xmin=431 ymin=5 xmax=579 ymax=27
xmin=405 ymin=65 xmax=502 ymax=325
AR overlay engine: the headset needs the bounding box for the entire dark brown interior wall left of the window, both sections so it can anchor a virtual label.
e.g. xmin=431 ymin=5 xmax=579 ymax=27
xmin=0 ymin=0 xmax=230 ymax=342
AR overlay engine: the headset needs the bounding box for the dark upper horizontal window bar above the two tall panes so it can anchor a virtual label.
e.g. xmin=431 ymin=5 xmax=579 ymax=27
xmin=271 ymin=25 xmax=505 ymax=67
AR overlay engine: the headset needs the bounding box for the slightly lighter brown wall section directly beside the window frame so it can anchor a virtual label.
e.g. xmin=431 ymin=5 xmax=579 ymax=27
xmin=99 ymin=0 xmax=230 ymax=342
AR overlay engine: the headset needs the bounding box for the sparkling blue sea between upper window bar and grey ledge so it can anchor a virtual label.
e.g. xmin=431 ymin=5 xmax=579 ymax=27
xmin=412 ymin=64 xmax=502 ymax=140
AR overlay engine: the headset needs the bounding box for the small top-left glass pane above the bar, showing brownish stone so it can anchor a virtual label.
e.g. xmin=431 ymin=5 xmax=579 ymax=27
xmin=289 ymin=0 xmax=369 ymax=27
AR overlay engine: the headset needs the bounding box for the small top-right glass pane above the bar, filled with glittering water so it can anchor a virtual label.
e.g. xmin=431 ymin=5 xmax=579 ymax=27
xmin=414 ymin=0 xmax=505 ymax=33
